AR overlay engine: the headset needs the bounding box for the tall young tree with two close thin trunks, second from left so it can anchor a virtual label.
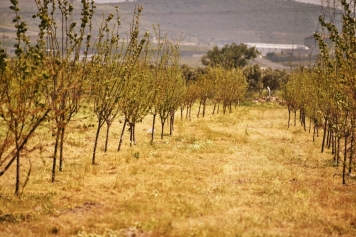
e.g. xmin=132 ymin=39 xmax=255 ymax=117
xmin=34 ymin=0 xmax=95 ymax=182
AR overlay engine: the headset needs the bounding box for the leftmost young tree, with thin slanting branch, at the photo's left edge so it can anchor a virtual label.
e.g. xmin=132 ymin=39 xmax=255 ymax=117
xmin=0 ymin=0 xmax=50 ymax=195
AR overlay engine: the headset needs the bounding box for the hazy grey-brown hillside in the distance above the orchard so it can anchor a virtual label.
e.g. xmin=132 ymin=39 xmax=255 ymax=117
xmin=0 ymin=0 xmax=321 ymax=47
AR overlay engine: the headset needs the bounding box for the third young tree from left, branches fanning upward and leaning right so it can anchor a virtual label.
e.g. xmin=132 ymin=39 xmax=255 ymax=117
xmin=91 ymin=6 xmax=149 ymax=164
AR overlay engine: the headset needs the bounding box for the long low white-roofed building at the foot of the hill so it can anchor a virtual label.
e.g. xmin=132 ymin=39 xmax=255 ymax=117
xmin=245 ymin=43 xmax=309 ymax=56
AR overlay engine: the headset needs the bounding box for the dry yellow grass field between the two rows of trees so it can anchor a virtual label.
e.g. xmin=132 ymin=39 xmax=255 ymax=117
xmin=0 ymin=105 xmax=356 ymax=237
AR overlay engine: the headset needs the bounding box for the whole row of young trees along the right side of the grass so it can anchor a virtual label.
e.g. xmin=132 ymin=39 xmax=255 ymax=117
xmin=284 ymin=0 xmax=356 ymax=184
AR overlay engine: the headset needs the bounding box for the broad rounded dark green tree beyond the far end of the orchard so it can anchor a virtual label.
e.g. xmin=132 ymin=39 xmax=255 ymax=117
xmin=201 ymin=43 xmax=259 ymax=69
